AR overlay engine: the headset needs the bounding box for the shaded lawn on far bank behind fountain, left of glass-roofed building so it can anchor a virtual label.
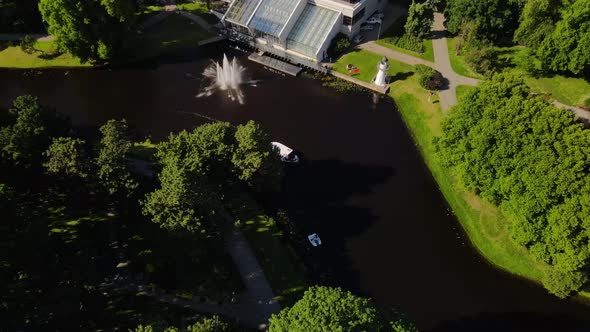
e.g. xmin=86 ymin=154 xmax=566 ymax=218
xmin=125 ymin=15 xmax=213 ymax=60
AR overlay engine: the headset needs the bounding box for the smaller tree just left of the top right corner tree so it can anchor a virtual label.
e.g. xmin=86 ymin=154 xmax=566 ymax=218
xmin=514 ymin=0 xmax=561 ymax=51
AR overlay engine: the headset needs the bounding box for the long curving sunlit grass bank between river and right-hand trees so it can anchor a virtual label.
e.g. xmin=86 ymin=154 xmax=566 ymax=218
xmin=335 ymin=51 xmax=547 ymax=281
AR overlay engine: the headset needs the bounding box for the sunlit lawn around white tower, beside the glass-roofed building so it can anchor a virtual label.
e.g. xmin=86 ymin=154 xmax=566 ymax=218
xmin=332 ymin=50 xmax=413 ymax=82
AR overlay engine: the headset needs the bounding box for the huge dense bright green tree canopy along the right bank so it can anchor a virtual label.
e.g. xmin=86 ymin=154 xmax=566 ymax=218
xmin=437 ymin=74 xmax=590 ymax=296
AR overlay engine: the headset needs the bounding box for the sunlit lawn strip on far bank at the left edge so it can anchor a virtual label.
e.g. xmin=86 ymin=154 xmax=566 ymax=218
xmin=0 ymin=41 xmax=90 ymax=68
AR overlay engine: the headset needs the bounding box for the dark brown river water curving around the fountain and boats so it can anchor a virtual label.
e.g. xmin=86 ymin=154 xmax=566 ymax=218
xmin=0 ymin=47 xmax=590 ymax=331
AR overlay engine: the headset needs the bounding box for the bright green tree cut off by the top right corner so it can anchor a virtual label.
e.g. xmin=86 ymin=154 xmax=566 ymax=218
xmin=537 ymin=0 xmax=590 ymax=75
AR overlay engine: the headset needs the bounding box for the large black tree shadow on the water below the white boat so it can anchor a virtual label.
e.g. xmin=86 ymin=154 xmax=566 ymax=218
xmin=285 ymin=159 xmax=395 ymax=289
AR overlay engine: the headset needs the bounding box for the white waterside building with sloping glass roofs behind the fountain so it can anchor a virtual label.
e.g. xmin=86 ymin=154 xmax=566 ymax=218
xmin=222 ymin=0 xmax=387 ymax=63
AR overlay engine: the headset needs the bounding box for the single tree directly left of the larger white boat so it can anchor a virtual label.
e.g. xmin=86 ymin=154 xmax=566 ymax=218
xmin=232 ymin=121 xmax=283 ymax=191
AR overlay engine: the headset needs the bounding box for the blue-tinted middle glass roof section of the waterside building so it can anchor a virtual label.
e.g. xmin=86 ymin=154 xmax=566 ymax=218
xmin=249 ymin=0 xmax=302 ymax=37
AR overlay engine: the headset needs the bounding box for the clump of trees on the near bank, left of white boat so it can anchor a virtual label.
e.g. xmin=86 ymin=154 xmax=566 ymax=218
xmin=144 ymin=121 xmax=282 ymax=231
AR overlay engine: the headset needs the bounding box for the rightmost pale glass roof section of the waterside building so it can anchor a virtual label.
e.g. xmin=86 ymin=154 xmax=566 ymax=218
xmin=287 ymin=4 xmax=339 ymax=58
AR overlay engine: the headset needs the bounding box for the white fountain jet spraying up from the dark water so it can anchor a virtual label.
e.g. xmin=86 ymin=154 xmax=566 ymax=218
xmin=197 ymin=54 xmax=253 ymax=104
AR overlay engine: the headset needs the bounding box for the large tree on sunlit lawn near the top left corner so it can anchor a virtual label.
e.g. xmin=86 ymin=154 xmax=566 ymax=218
xmin=39 ymin=0 xmax=136 ymax=62
